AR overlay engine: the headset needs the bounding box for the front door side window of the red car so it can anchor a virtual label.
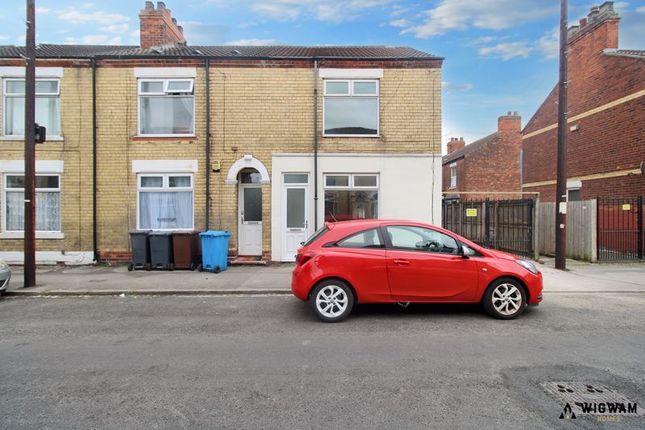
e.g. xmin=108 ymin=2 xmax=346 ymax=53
xmin=385 ymin=225 xmax=459 ymax=254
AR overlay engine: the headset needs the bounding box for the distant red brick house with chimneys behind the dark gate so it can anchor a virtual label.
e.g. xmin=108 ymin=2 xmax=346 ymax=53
xmin=442 ymin=112 xmax=522 ymax=200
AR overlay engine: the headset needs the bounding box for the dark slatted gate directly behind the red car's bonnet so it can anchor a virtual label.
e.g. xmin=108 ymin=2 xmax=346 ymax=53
xmin=442 ymin=199 xmax=536 ymax=257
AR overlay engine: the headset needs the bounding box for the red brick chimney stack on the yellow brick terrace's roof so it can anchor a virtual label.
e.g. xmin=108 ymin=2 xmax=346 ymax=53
xmin=139 ymin=1 xmax=186 ymax=49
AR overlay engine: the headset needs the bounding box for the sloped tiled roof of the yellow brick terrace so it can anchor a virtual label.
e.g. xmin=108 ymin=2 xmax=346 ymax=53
xmin=0 ymin=44 xmax=441 ymax=60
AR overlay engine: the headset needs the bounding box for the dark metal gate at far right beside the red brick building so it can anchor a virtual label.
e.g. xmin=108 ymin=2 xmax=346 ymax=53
xmin=597 ymin=196 xmax=645 ymax=261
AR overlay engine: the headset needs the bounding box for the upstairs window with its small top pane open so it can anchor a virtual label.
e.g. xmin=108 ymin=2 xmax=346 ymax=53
xmin=138 ymin=78 xmax=195 ymax=137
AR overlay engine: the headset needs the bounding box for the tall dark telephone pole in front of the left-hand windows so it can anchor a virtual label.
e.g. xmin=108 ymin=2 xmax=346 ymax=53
xmin=24 ymin=0 xmax=36 ymax=287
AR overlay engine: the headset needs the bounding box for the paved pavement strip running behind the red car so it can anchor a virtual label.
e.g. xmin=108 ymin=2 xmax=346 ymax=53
xmin=9 ymin=260 xmax=645 ymax=295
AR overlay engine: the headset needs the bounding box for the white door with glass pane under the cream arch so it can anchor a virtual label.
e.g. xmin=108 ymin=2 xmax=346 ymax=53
xmin=237 ymin=184 xmax=262 ymax=255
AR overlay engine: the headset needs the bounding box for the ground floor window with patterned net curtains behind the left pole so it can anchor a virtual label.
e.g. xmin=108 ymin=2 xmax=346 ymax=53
xmin=3 ymin=173 xmax=61 ymax=232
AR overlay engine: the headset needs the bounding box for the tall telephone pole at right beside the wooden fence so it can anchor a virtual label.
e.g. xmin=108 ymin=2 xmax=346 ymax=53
xmin=555 ymin=0 xmax=568 ymax=270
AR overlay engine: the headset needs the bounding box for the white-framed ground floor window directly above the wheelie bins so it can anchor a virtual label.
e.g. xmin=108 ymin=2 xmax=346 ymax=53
xmin=137 ymin=173 xmax=194 ymax=230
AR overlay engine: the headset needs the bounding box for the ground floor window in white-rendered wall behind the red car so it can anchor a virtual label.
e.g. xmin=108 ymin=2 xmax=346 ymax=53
xmin=324 ymin=173 xmax=379 ymax=222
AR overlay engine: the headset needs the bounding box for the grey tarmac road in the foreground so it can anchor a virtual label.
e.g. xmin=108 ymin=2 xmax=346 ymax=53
xmin=0 ymin=293 xmax=645 ymax=429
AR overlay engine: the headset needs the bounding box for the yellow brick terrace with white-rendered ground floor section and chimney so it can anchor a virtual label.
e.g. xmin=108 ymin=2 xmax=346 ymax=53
xmin=0 ymin=2 xmax=442 ymax=263
